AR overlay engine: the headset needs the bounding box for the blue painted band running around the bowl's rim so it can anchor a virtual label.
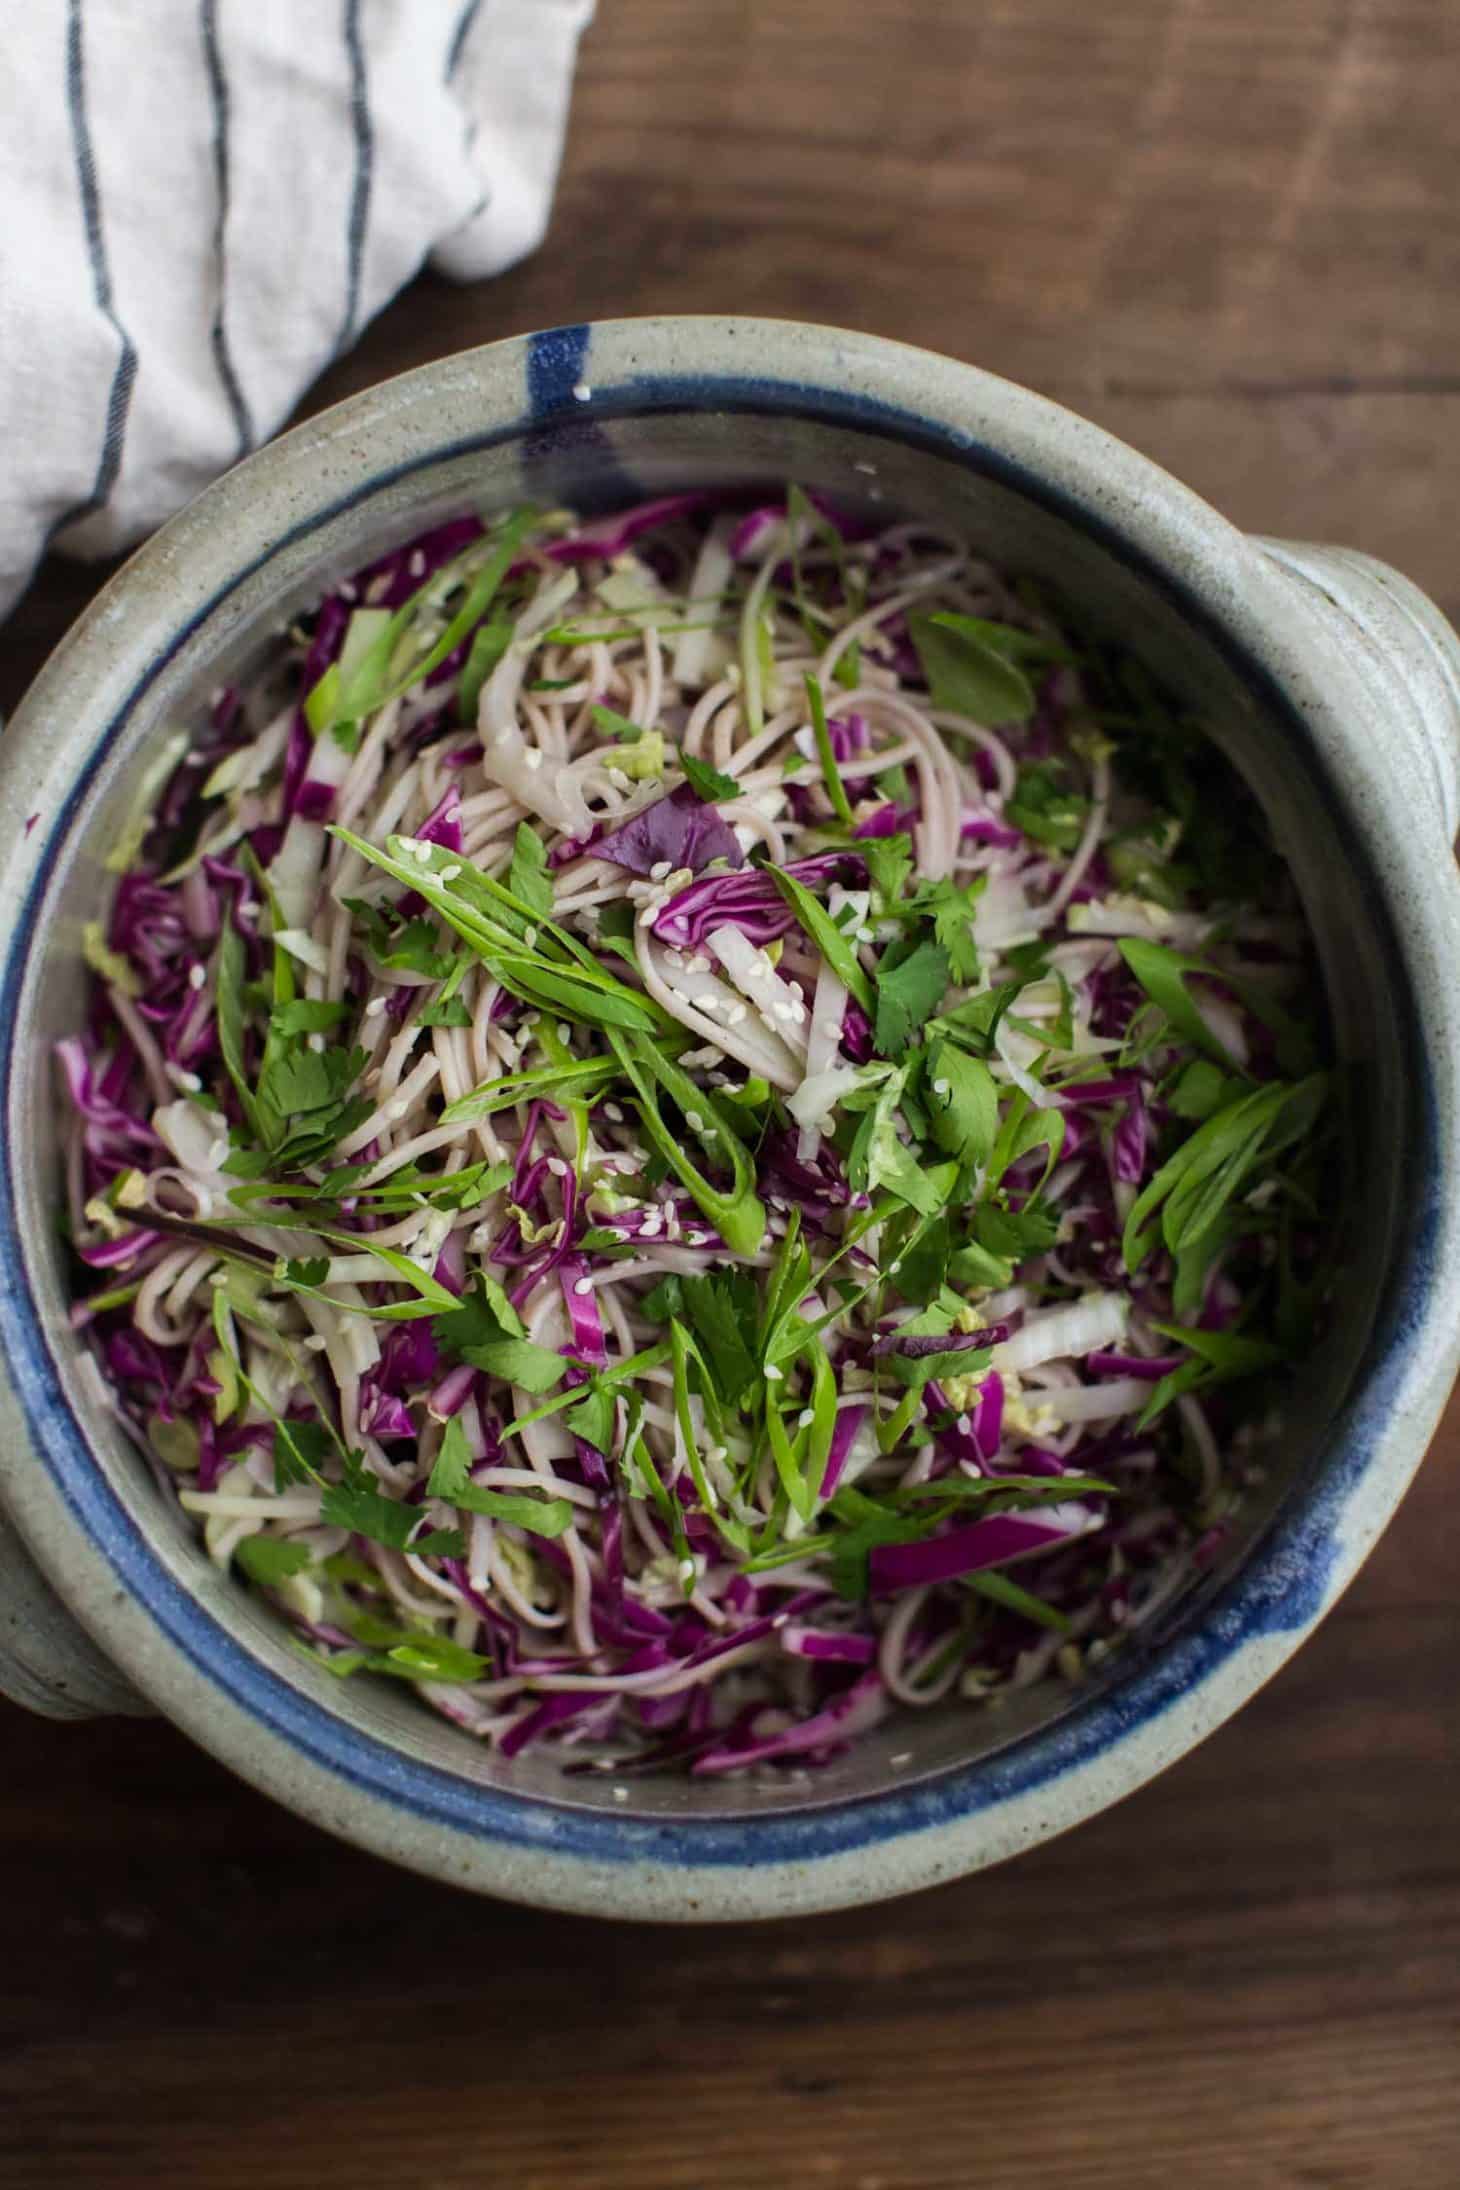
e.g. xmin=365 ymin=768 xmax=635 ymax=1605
xmin=0 ymin=326 xmax=1442 ymax=1870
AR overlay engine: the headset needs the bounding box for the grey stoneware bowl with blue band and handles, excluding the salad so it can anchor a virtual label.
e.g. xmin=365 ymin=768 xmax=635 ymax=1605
xmin=0 ymin=320 xmax=1460 ymax=1918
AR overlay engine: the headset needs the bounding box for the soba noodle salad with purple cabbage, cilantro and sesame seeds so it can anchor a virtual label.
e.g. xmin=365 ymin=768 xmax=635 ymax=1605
xmin=59 ymin=488 xmax=1331 ymax=1774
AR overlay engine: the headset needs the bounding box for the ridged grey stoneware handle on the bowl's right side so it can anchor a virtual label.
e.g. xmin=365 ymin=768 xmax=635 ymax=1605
xmin=1256 ymin=539 xmax=1460 ymax=843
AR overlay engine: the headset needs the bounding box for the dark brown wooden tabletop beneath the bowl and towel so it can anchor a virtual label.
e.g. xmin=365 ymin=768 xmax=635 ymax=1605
xmin=0 ymin=0 xmax=1460 ymax=2190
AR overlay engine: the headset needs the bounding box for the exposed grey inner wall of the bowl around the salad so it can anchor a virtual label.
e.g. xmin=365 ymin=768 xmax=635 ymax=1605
xmin=4 ymin=394 xmax=1416 ymax=1818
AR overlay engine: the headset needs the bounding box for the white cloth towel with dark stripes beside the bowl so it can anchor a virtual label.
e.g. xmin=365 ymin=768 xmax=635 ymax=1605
xmin=0 ymin=0 xmax=593 ymax=615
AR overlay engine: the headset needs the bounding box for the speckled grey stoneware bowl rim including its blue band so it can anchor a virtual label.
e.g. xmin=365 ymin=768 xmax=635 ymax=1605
xmin=0 ymin=318 xmax=1460 ymax=1918
